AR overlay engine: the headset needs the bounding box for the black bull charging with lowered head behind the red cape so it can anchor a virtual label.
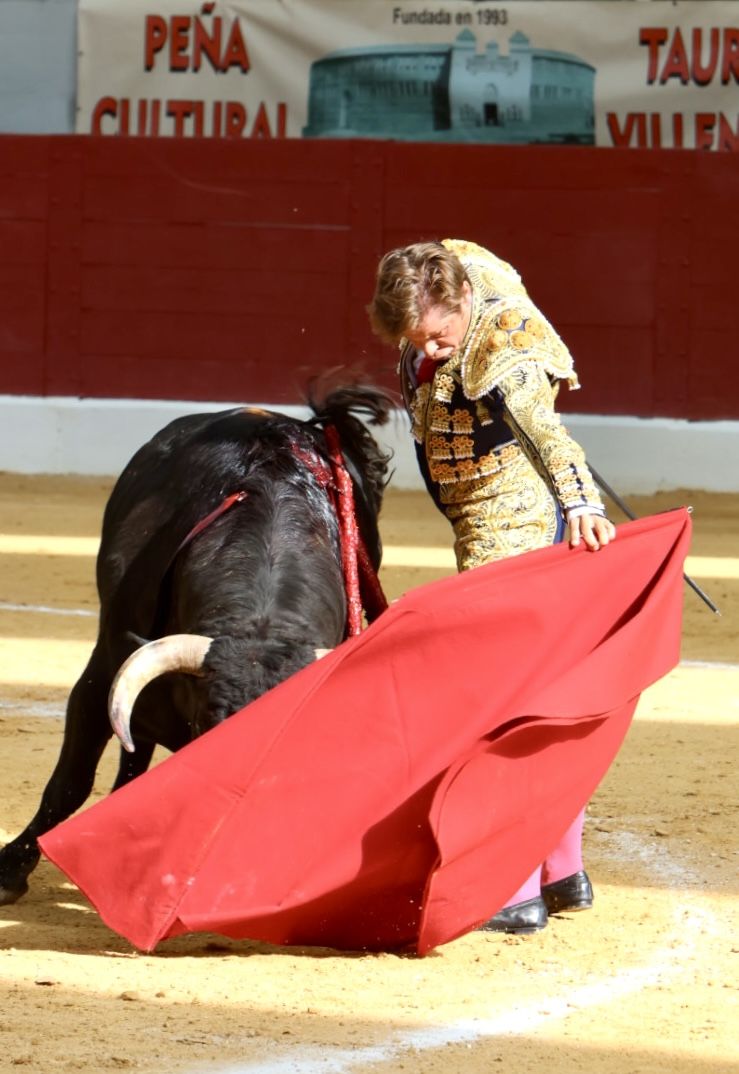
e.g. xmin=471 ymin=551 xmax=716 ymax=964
xmin=0 ymin=386 xmax=391 ymax=903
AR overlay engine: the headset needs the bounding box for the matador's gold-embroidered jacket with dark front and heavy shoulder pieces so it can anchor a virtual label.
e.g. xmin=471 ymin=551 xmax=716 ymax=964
xmin=399 ymin=240 xmax=603 ymax=551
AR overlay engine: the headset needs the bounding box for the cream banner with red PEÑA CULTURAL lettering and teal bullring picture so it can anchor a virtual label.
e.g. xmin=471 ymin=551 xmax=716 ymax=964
xmin=77 ymin=0 xmax=739 ymax=150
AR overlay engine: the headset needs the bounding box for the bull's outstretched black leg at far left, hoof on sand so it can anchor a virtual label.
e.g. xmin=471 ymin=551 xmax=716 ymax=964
xmin=0 ymin=656 xmax=113 ymax=905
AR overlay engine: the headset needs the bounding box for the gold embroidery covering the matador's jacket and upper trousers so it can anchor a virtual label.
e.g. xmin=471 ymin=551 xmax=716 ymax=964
xmin=406 ymin=240 xmax=600 ymax=569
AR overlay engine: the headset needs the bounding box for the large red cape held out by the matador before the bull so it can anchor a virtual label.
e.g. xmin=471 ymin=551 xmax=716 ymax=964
xmin=40 ymin=509 xmax=690 ymax=954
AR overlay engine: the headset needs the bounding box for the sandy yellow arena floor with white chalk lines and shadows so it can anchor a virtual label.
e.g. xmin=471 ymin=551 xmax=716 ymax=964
xmin=0 ymin=475 xmax=739 ymax=1074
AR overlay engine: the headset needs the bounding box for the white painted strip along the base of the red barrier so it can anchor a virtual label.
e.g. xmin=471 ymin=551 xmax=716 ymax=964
xmin=0 ymin=395 xmax=739 ymax=495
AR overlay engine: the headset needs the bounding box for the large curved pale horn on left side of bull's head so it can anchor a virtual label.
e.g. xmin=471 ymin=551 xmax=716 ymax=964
xmin=107 ymin=634 xmax=213 ymax=753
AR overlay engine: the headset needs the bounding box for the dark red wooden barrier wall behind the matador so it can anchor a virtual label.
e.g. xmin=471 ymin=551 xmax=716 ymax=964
xmin=0 ymin=135 xmax=739 ymax=419
